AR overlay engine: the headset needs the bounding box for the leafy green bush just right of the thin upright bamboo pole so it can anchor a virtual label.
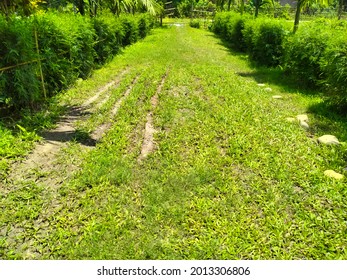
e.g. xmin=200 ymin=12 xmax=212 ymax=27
xmin=33 ymin=13 xmax=96 ymax=95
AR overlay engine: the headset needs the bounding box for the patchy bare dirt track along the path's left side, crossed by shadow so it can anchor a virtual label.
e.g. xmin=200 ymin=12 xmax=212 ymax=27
xmin=0 ymin=69 xmax=135 ymax=259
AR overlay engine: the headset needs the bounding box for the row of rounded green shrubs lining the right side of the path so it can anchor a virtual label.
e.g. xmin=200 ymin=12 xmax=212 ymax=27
xmin=212 ymin=12 xmax=347 ymax=107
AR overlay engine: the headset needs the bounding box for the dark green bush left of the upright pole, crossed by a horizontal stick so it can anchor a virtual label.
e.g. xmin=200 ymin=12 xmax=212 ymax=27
xmin=0 ymin=17 xmax=40 ymax=108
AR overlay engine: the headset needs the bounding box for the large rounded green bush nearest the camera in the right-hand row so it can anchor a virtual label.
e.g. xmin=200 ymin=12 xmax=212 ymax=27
xmin=284 ymin=19 xmax=347 ymax=107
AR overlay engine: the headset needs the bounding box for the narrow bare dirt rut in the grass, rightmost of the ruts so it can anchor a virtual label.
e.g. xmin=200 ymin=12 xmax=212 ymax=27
xmin=137 ymin=70 xmax=169 ymax=162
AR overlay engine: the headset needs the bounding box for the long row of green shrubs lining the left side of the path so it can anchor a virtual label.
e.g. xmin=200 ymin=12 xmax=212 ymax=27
xmin=0 ymin=12 xmax=154 ymax=109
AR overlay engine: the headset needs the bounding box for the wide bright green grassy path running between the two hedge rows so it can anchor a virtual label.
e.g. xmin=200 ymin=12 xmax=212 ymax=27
xmin=0 ymin=22 xmax=347 ymax=259
